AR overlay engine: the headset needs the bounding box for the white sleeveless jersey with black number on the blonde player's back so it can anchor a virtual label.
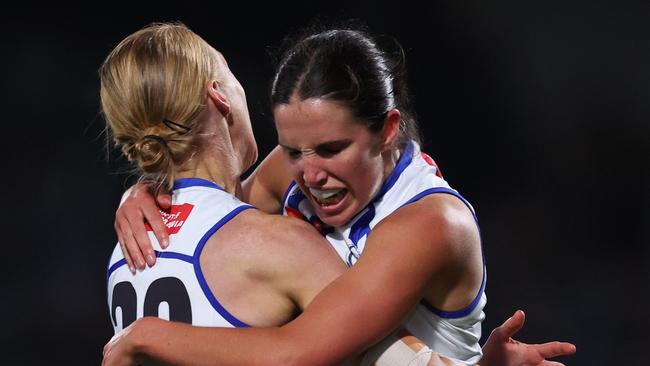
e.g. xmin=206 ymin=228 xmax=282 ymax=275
xmin=107 ymin=178 xmax=252 ymax=333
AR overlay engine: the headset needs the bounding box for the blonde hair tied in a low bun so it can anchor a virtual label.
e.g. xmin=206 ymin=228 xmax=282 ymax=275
xmin=99 ymin=23 xmax=218 ymax=189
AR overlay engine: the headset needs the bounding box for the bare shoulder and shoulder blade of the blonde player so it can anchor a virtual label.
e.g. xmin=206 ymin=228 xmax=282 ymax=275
xmin=200 ymin=210 xmax=345 ymax=326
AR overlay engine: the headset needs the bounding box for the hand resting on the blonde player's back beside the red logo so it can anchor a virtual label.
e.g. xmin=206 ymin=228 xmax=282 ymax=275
xmin=115 ymin=183 xmax=171 ymax=273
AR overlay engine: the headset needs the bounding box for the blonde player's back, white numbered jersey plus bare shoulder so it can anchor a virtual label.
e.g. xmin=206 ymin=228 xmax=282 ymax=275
xmin=108 ymin=178 xmax=346 ymax=332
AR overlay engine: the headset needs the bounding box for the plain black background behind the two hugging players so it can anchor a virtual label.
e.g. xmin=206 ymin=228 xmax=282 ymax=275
xmin=0 ymin=0 xmax=650 ymax=365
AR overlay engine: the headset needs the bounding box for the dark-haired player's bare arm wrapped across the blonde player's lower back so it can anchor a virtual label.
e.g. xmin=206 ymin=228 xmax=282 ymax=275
xmin=104 ymin=196 xmax=464 ymax=365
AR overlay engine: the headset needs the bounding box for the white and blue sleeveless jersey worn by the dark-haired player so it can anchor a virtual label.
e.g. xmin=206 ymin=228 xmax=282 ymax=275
xmin=283 ymin=142 xmax=487 ymax=364
